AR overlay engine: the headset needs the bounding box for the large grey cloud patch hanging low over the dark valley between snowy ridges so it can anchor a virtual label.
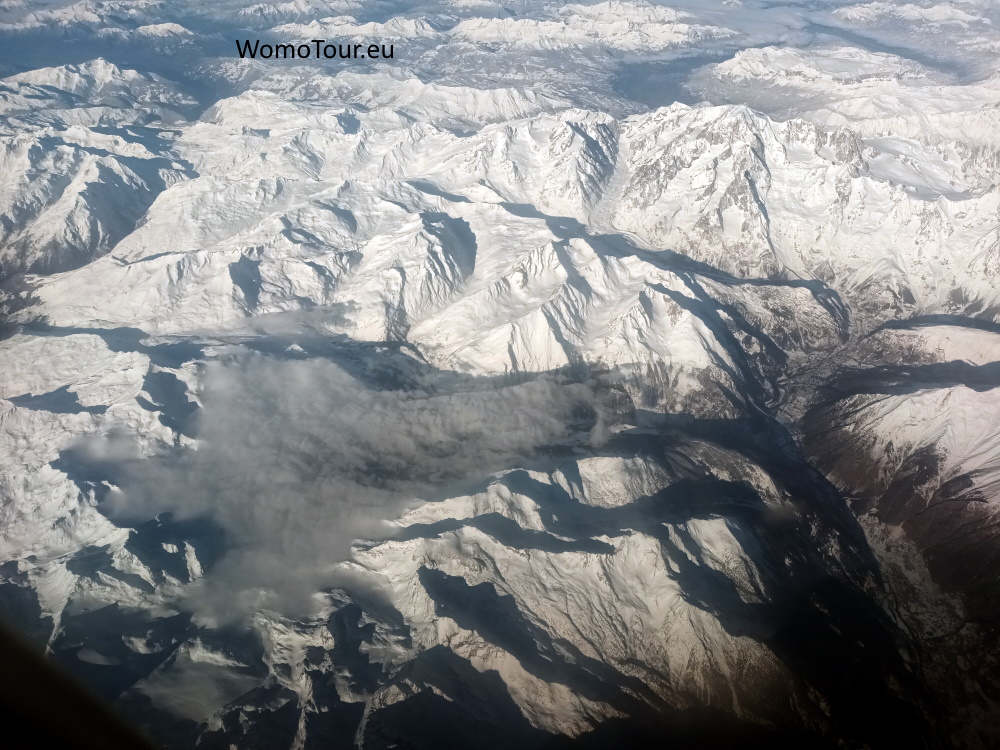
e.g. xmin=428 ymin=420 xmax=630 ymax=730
xmin=99 ymin=355 xmax=598 ymax=620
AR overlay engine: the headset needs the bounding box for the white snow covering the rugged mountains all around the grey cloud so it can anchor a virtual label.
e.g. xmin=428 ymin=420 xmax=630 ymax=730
xmin=0 ymin=0 xmax=1000 ymax=747
